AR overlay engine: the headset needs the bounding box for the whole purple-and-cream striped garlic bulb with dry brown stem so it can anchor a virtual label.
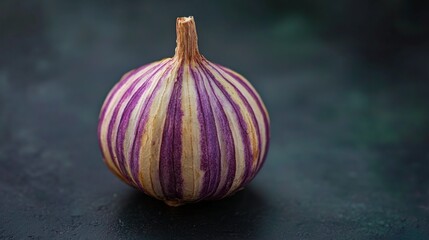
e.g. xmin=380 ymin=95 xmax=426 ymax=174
xmin=98 ymin=17 xmax=270 ymax=206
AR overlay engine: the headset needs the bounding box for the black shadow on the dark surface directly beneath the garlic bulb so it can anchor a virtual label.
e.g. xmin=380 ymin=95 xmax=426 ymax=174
xmin=111 ymin=188 xmax=265 ymax=239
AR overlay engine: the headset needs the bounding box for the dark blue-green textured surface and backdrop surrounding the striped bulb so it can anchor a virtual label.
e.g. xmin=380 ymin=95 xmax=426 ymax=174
xmin=0 ymin=1 xmax=429 ymax=239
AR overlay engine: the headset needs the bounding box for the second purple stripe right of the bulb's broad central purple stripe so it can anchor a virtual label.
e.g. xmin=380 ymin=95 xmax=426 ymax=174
xmin=203 ymin=68 xmax=236 ymax=199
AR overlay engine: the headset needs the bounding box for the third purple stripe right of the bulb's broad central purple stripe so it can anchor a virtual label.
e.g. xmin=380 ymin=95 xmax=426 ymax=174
xmin=200 ymin=64 xmax=252 ymax=193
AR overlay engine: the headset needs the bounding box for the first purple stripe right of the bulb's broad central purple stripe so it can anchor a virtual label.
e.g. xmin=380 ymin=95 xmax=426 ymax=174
xmin=191 ymin=68 xmax=220 ymax=199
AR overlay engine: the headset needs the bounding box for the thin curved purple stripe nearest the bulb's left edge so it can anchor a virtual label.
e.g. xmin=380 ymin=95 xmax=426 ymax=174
xmin=107 ymin=63 xmax=170 ymax=181
